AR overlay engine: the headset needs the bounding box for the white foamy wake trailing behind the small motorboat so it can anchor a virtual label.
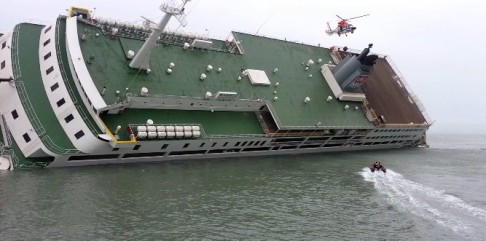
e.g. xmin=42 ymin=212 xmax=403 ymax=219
xmin=360 ymin=168 xmax=486 ymax=236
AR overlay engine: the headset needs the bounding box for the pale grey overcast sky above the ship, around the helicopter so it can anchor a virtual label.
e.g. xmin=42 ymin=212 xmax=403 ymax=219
xmin=0 ymin=0 xmax=486 ymax=133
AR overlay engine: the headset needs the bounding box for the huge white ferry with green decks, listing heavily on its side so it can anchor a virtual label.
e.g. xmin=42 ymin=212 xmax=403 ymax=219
xmin=0 ymin=1 xmax=431 ymax=169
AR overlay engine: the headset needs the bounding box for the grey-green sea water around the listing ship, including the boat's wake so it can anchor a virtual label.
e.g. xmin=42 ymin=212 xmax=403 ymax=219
xmin=0 ymin=134 xmax=486 ymax=240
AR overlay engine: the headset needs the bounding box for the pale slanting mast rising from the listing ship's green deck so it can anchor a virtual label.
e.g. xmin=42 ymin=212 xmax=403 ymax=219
xmin=129 ymin=0 xmax=190 ymax=70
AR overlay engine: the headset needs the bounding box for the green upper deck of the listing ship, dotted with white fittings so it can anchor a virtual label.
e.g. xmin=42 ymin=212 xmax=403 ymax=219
xmin=78 ymin=22 xmax=373 ymax=134
